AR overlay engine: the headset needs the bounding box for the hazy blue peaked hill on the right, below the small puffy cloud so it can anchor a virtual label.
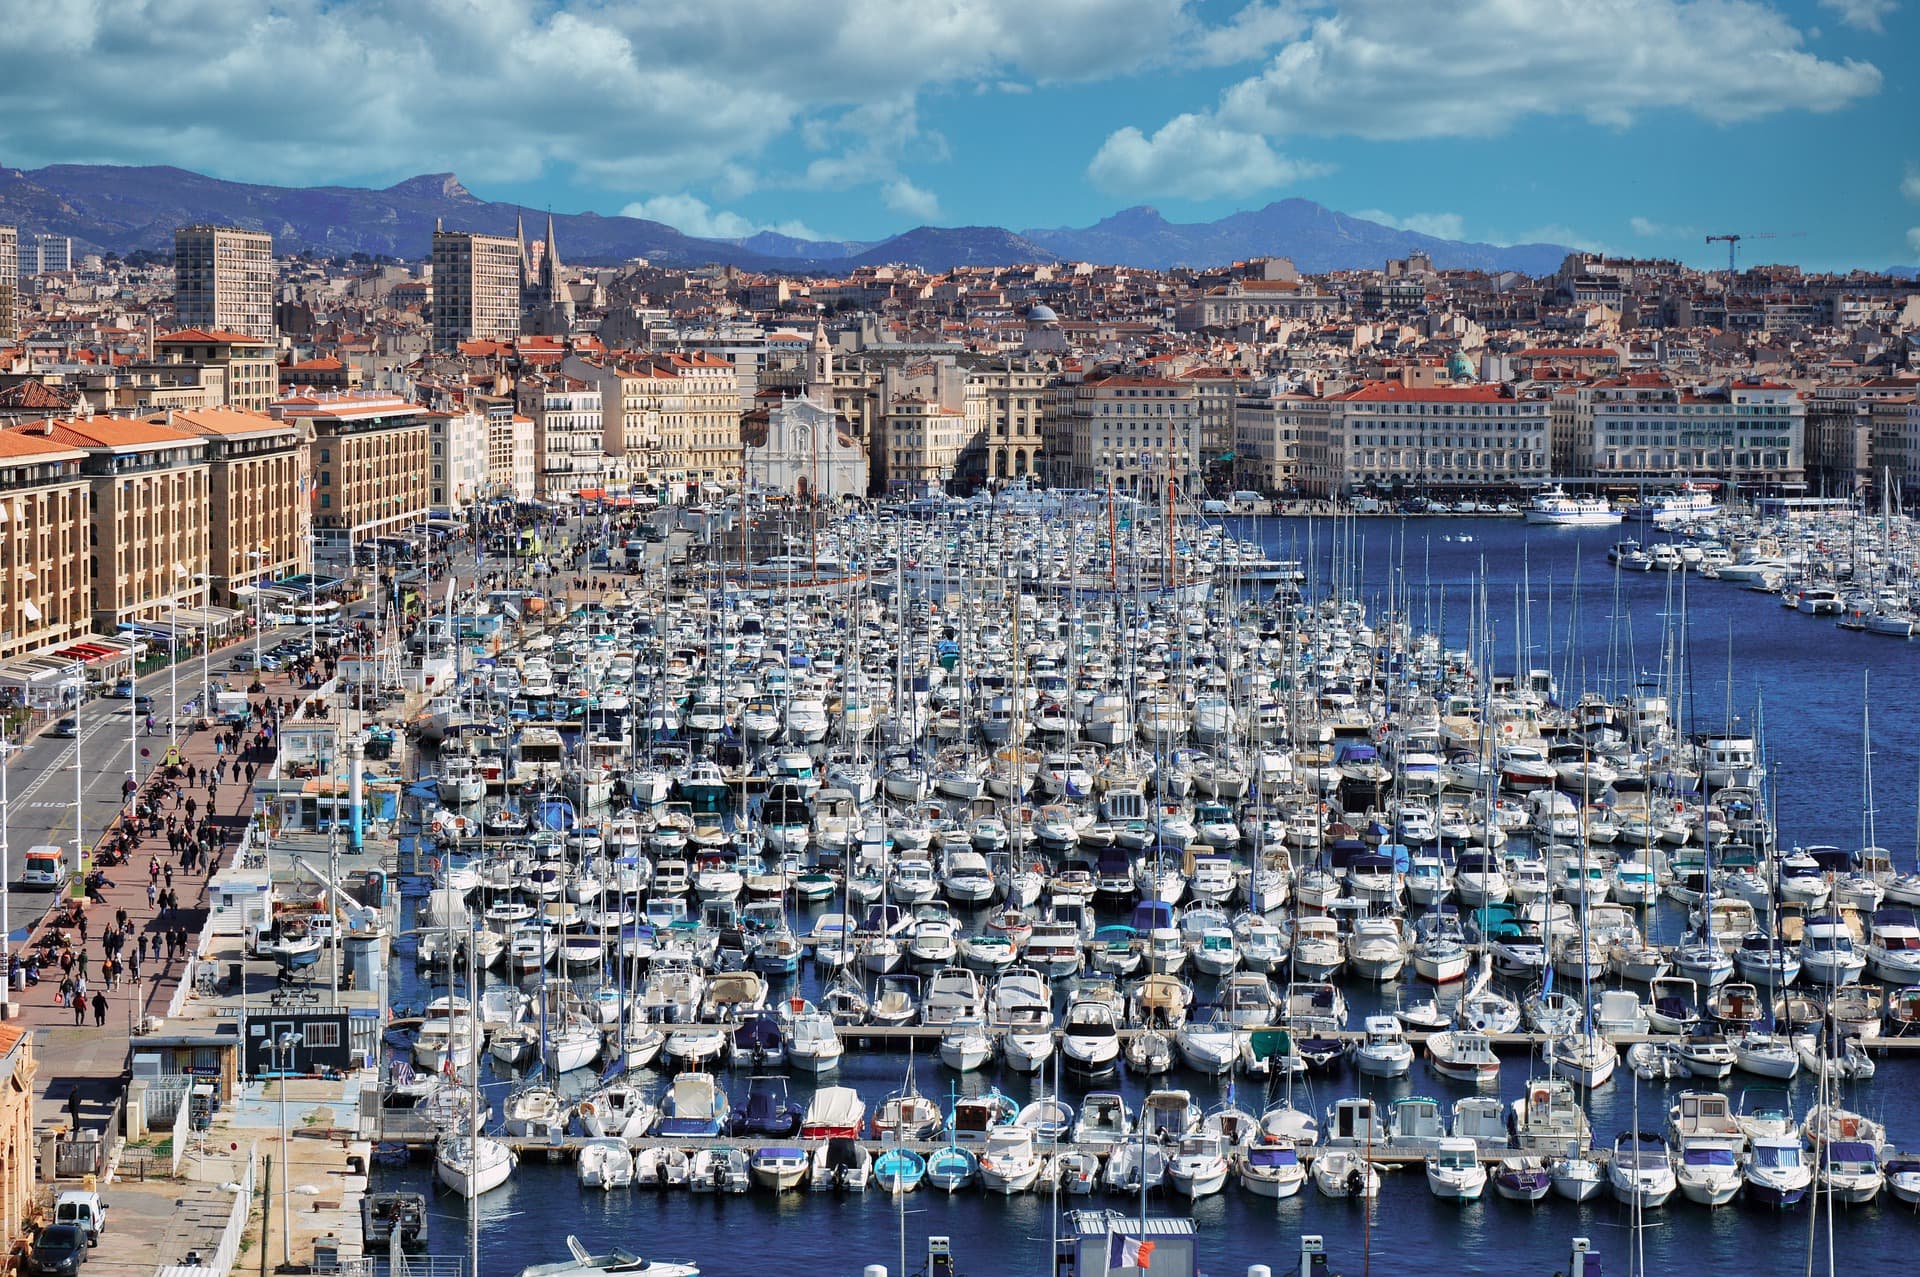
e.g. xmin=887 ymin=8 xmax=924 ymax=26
xmin=1023 ymin=200 xmax=1572 ymax=275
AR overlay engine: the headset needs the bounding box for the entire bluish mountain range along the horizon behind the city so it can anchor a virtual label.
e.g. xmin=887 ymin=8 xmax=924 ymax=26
xmin=0 ymin=163 xmax=1571 ymax=275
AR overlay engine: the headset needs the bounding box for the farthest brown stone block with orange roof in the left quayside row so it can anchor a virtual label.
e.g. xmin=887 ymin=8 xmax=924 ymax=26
xmin=273 ymin=394 xmax=430 ymax=559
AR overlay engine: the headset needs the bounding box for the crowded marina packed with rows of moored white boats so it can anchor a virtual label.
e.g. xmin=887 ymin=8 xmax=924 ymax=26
xmin=307 ymin=503 xmax=1920 ymax=1271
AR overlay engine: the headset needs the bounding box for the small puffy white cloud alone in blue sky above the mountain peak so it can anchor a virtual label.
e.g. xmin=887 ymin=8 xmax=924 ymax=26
xmin=1087 ymin=115 xmax=1325 ymax=200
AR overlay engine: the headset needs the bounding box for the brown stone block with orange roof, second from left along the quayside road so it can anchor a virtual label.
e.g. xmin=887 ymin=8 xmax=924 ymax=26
xmin=13 ymin=417 xmax=211 ymax=634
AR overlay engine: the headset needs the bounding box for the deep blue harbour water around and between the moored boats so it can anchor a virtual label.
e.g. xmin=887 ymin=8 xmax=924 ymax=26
xmin=380 ymin=520 xmax=1920 ymax=1277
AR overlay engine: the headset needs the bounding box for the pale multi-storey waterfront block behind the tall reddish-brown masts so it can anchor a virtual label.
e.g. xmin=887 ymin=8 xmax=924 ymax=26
xmin=1052 ymin=376 xmax=1200 ymax=501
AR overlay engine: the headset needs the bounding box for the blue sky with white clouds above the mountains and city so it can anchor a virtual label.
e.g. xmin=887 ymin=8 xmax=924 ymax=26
xmin=0 ymin=0 xmax=1920 ymax=269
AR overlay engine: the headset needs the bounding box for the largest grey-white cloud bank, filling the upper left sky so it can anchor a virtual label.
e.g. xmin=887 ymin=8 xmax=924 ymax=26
xmin=0 ymin=0 xmax=1198 ymax=200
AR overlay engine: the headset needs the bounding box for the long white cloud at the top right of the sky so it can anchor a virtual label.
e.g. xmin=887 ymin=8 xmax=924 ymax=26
xmin=1217 ymin=0 xmax=1880 ymax=140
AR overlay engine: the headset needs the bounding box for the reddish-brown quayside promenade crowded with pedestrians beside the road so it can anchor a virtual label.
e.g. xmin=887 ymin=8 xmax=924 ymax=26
xmin=12 ymin=639 xmax=305 ymax=1137
